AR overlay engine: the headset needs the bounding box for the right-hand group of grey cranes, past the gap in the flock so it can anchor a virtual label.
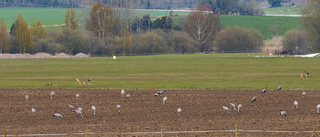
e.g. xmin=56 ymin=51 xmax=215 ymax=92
xmin=222 ymin=82 xmax=320 ymax=117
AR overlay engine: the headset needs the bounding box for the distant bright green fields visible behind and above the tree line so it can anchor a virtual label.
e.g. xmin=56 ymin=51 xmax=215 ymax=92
xmin=0 ymin=8 xmax=300 ymax=39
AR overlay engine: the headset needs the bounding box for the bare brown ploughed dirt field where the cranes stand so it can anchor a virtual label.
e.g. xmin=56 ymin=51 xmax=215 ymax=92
xmin=0 ymin=89 xmax=320 ymax=137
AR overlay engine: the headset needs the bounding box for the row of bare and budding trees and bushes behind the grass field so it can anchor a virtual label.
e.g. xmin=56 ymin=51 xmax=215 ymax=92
xmin=0 ymin=1 xmax=320 ymax=56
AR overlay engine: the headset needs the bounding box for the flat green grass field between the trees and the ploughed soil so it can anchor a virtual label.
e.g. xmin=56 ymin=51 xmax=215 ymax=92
xmin=0 ymin=54 xmax=320 ymax=90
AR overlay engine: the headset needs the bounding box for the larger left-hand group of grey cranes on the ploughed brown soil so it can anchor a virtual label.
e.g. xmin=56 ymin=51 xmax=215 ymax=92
xmin=25 ymin=89 xmax=181 ymax=119
